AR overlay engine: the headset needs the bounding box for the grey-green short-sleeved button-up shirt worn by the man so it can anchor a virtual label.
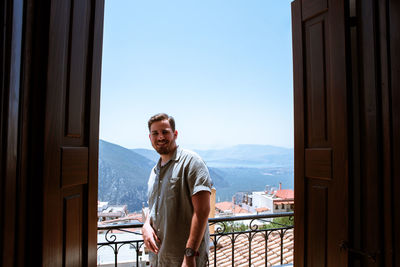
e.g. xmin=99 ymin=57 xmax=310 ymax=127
xmin=148 ymin=147 xmax=212 ymax=267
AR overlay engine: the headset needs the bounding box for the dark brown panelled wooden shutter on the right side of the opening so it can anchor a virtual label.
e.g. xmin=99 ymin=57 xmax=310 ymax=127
xmin=292 ymin=0 xmax=348 ymax=267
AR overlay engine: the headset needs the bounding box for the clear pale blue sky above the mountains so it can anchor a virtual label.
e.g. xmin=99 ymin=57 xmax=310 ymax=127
xmin=100 ymin=0 xmax=293 ymax=149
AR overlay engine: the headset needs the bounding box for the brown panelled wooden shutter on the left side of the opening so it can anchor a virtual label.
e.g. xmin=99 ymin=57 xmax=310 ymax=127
xmin=42 ymin=0 xmax=104 ymax=266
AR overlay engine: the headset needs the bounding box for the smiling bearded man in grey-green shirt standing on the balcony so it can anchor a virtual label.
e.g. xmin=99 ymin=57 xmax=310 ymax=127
xmin=142 ymin=113 xmax=212 ymax=267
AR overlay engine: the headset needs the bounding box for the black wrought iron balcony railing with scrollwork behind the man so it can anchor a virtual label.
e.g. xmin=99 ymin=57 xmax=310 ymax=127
xmin=97 ymin=212 xmax=294 ymax=267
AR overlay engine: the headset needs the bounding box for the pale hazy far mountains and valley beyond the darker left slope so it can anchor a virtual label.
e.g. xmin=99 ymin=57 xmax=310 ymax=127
xmin=132 ymin=145 xmax=294 ymax=201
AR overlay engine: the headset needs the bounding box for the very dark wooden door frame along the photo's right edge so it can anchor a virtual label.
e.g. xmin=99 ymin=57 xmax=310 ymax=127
xmin=349 ymin=0 xmax=400 ymax=266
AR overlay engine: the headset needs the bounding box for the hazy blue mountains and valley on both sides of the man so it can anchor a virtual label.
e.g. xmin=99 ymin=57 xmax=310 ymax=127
xmin=99 ymin=140 xmax=294 ymax=212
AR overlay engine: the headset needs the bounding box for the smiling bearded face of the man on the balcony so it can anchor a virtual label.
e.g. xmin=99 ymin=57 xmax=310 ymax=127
xmin=149 ymin=120 xmax=178 ymax=155
